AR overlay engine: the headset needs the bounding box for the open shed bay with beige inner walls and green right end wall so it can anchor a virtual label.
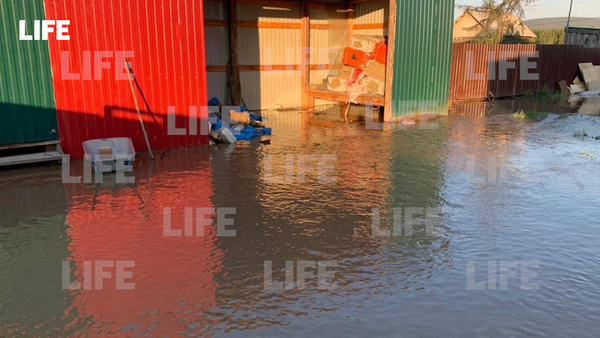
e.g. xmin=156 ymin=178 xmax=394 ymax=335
xmin=204 ymin=0 xmax=454 ymax=120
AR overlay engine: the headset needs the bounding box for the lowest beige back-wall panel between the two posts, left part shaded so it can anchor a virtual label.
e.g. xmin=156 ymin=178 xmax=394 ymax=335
xmin=240 ymin=71 xmax=301 ymax=110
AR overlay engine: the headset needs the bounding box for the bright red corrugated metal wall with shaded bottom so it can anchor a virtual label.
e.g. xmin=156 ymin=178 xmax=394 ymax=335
xmin=44 ymin=0 xmax=208 ymax=157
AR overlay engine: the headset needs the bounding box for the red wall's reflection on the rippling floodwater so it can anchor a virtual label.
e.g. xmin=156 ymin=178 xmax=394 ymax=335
xmin=65 ymin=149 xmax=217 ymax=334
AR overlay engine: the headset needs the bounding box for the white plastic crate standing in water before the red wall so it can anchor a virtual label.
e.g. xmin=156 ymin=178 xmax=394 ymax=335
xmin=82 ymin=137 xmax=136 ymax=173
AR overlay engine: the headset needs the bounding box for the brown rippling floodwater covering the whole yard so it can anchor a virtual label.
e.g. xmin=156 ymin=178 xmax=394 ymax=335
xmin=0 ymin=97 xmax=600 ymax=337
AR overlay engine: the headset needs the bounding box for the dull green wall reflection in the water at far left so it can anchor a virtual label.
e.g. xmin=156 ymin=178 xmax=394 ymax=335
xmin=0 ymin=166 xmax=69 ymax=336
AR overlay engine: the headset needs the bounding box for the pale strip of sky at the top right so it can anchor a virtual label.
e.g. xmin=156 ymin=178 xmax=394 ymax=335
xmin=455 ymin=0 xmax=600 ymax=19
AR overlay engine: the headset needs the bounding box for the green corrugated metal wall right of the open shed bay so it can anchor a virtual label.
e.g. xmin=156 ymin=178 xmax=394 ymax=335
xmin=392 ymin=0 xmax=454 ymax=117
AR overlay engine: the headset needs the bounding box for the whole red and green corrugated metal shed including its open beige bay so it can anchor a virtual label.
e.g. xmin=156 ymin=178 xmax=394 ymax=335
xmin=0 ymin=0 xmax=454 ymax=157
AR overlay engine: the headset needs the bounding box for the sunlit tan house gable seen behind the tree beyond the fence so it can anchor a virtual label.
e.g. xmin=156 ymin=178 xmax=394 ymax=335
xmin=454 ymin=9 xmax=537 ymax=40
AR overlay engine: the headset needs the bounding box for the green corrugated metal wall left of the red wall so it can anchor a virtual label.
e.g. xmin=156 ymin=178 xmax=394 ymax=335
xmin=0 ymin=0 xmax=58 ymax=145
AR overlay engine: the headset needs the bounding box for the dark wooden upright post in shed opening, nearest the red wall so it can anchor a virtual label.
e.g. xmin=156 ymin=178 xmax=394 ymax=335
xmin=226 ymin=0 xmax=242 ymax=106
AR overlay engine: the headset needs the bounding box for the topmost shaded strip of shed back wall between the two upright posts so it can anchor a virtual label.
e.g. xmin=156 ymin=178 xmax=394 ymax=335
xmin=237 ymin=3 xmax=301 ymax=23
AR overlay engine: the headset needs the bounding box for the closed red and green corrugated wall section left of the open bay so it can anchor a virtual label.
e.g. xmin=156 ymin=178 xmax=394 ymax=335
xmin=0 ymin=0 xmax=208 ymax=157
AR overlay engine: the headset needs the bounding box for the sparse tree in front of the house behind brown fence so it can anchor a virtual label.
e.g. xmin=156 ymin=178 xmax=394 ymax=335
xmin=461 ymin=0 xmax=537 ymax=44
